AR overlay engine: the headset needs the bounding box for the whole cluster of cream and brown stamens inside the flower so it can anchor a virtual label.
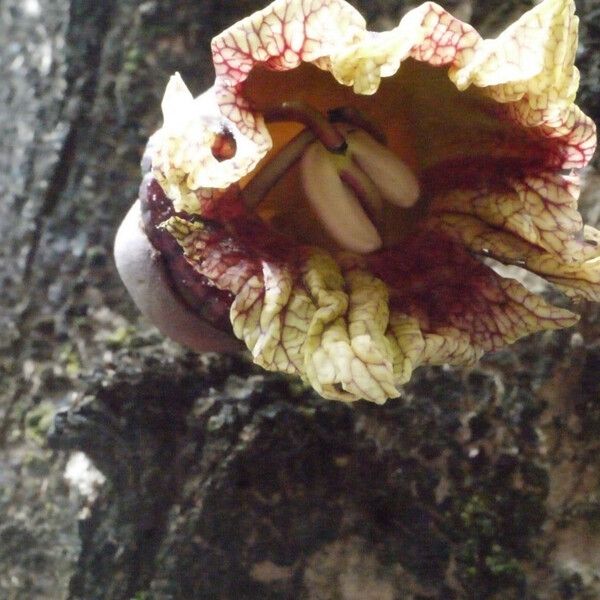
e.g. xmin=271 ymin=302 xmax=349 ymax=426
xmin=243 ymin=103 xmax=420 ymax=254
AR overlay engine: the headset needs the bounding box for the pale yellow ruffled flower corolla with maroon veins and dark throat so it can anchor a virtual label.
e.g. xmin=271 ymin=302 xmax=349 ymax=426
xmin=116 ymin=0 xmax=600 ymax=403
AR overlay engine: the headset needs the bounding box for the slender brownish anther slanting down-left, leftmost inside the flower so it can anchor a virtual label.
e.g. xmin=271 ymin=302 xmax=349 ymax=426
xmin=242 ymin=129 xmax=315 ymax=209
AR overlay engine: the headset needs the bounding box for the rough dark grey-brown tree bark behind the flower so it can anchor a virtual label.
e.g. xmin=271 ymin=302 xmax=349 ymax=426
xmin=0 ymin=0 xmax=600 ymax=600
